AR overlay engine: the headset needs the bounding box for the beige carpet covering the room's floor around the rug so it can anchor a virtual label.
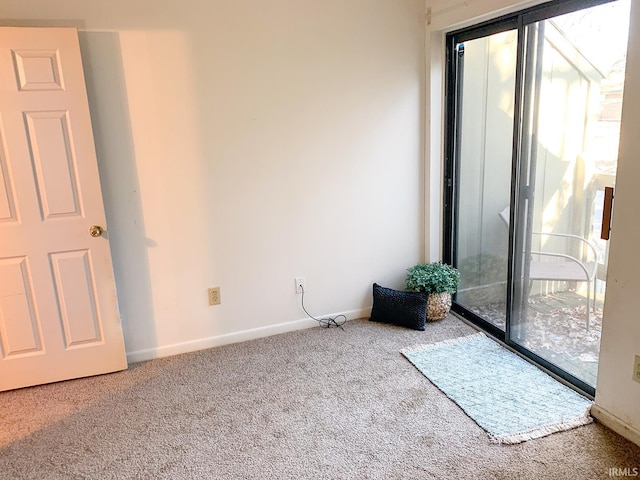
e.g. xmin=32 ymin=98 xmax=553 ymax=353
xmin=0 ymin=317 xmax=640 ymax=480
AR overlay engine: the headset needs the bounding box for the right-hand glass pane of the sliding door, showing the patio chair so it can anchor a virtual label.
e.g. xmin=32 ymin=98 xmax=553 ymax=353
xmin=510 ymin=1 xmax=629 ymax=387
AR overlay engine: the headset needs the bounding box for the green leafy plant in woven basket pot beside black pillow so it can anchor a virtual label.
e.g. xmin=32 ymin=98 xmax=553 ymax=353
xmin=406 ymin=262 xmax=460 ymax=322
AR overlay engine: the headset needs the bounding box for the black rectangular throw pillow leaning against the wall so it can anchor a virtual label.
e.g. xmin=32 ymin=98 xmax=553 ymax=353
xmin=369 ymin=283 xmax=429 ymax=330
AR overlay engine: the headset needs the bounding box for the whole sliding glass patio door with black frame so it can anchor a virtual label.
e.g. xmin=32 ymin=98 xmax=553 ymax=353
xmin=445 ymin=0 xmax=629 ymax=394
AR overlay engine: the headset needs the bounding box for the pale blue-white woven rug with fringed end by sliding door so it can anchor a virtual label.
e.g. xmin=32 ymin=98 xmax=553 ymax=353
xmin=401 ymin=333 xmax=593 ymax=444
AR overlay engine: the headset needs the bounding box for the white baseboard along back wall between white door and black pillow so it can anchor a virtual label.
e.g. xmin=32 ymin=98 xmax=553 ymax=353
xmin=127 ymin=308 xmax=371 ymax=363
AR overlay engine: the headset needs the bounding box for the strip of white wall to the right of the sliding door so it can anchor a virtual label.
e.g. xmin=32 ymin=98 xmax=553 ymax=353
xmin=596 ymin=1 xmax=640 ymax=442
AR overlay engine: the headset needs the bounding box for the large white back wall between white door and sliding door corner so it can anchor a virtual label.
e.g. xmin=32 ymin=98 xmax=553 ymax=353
xmin=0 ymin=0 xmax=425 ymax=359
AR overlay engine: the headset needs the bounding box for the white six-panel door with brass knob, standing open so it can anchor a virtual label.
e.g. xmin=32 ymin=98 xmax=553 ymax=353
xmin=0 ymin=28 xmax=127 ymax=391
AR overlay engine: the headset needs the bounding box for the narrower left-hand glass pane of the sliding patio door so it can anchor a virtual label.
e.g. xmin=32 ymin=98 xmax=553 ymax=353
xmin=454 ymin=30 xmax=517 ymax=331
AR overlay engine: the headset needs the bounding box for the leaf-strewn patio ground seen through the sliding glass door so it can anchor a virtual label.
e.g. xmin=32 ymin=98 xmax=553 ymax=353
xmin=462 ymin=291 xmax=602 ymax=386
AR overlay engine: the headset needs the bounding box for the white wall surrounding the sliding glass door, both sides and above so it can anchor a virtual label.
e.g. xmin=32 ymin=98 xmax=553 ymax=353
xmin=426 ymin=0 xmax=640 ymax=443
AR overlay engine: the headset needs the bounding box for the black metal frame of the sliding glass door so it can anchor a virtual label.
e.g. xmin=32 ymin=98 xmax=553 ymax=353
xmin=442 ymin=0 xmax=615 ymax=398
